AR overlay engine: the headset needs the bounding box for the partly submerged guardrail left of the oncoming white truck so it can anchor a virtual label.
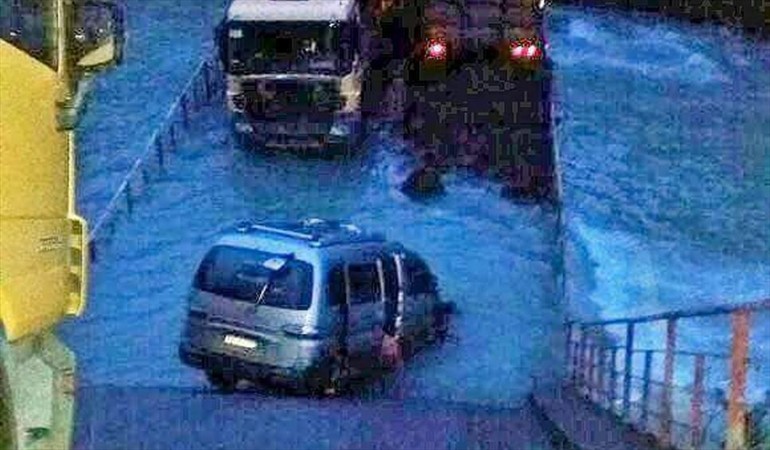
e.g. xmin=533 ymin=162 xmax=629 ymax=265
xmin=88 ymin=59 xmax=224 ymax=260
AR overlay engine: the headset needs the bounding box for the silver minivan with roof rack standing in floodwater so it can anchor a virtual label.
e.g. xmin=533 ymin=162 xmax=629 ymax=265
xmin=179 ymin=219 xmax=451 ymax=392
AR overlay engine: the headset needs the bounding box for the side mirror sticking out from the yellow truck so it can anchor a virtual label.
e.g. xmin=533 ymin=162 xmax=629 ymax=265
xmin=70 ymin=0 xmax=125 ymax=71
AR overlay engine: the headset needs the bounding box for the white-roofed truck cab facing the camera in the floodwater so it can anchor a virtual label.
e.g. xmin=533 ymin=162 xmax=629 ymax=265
xmin=216 ymin=0 xmax=362 ymax=151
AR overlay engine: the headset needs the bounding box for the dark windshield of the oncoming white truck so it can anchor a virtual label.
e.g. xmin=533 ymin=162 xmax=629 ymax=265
xmin=227 ymin=22 xmax=352 ymax=75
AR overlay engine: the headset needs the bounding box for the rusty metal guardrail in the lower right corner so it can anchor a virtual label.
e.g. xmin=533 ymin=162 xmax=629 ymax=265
xmin=565 ymin=299 xmax=770 ymax=450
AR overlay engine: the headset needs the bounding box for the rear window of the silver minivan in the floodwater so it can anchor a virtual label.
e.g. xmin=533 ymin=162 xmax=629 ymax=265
xmin=193 ymin=246 xmax=313 ymax=310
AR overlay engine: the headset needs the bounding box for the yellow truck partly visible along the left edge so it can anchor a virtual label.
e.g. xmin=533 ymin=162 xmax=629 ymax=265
xmin=0 ymin=0 xmax=123 ymax=450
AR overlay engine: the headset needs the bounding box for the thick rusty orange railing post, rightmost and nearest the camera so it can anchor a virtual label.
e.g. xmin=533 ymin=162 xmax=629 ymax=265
xmin=726 ymin=311 xmax=751 ymax=450
